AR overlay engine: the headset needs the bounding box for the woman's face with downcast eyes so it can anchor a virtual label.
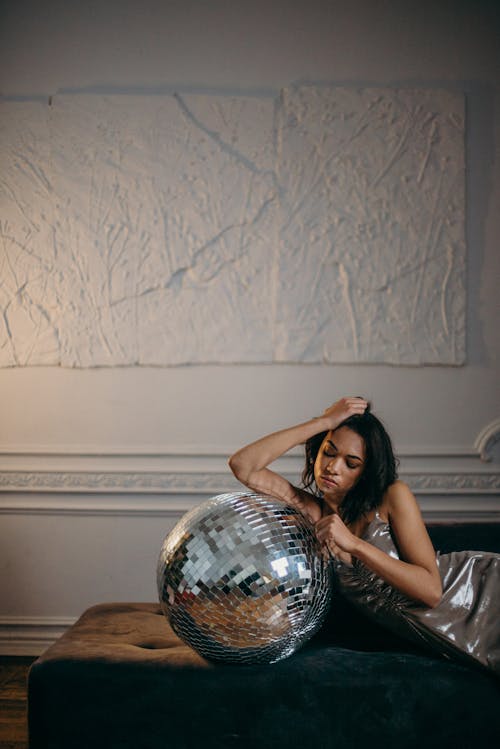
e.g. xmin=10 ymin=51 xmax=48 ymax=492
xmin=314 ymin=427 xmax=366 ymax=509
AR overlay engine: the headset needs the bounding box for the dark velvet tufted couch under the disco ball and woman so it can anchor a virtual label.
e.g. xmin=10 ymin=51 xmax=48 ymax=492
xmin=28 ymin=523 xmax=500 ymax=749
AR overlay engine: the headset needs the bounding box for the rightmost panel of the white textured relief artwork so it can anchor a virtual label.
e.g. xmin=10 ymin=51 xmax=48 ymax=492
xmin=276 ymin=87 xmax=465 ymax=364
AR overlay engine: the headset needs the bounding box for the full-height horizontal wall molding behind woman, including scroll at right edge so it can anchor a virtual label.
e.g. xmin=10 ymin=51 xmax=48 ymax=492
xmin=0 ymin=442 xmax=500 ymax=517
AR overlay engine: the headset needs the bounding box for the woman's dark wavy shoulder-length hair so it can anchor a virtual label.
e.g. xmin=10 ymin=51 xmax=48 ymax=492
xmin=302 ymin=405 xmax=398 ymax=523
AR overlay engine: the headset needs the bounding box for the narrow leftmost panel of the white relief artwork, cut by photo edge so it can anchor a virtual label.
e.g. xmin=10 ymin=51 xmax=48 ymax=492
xmin=0 ymin=102 xmax=59 ymax=366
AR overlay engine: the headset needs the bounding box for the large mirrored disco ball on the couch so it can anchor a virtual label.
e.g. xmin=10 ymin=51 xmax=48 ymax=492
xmin=157 ymin=492 xmax=331 ymax=663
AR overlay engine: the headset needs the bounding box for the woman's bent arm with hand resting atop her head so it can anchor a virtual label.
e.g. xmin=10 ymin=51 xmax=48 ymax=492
xmin=229 ymin=398 xmax=366 ymax=523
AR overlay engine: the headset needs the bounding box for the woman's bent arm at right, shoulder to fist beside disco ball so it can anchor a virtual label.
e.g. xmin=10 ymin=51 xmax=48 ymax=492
xmin=316 ymin=481 xmax=442 ymax=608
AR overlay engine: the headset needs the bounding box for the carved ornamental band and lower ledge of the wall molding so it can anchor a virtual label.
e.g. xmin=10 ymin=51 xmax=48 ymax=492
xmin=0 ymin=472 xmax=500 ymax=520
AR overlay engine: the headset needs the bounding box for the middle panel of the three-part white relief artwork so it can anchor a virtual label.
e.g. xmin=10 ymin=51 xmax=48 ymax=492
xmin=48 ymin=96 xmax=276 ymax=366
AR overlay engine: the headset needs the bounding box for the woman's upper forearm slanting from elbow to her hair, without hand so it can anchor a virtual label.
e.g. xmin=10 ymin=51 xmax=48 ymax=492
xmin=229 ymin=417 xmax=330 ymax=488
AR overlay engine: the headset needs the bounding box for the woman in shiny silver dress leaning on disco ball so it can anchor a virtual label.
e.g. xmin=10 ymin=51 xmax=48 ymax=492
xmin=229 ymin=397 xmax=500 ymax=675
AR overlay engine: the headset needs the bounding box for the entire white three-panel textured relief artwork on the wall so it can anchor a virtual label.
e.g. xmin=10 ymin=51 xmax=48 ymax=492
xmin=0 ymin=86 xmax=465 ymax=367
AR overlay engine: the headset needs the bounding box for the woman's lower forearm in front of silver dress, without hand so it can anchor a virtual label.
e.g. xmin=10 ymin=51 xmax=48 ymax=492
xmin=351 ymin=539 xmax=442 ymax=607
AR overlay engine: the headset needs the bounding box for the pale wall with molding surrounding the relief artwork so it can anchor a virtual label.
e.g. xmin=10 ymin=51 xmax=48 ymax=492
xmin=0 ymin=0 xmax=500 ymax=652
